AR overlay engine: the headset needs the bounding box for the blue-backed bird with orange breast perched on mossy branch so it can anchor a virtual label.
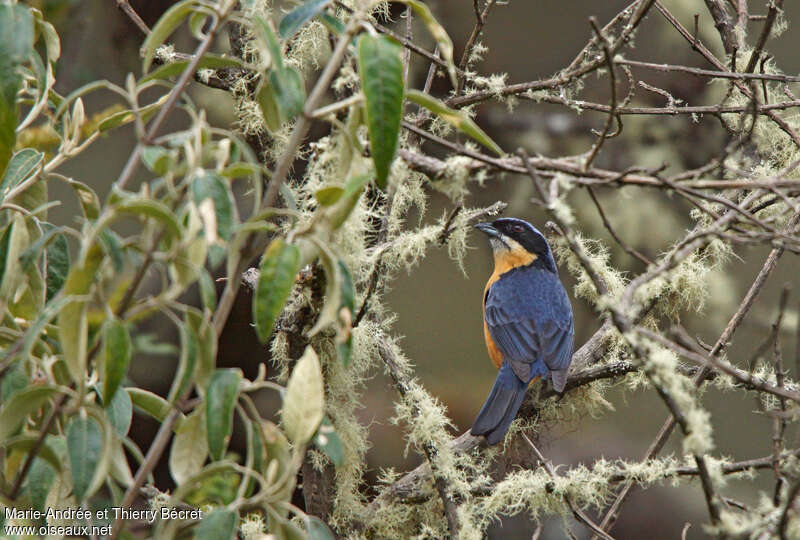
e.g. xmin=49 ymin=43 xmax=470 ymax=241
xmin=471 ymin=218 xmax=575 ymax=445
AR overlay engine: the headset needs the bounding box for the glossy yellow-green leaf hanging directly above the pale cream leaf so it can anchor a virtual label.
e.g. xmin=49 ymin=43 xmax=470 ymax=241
xmin=253 ymin=238 xmax=300 ymax=342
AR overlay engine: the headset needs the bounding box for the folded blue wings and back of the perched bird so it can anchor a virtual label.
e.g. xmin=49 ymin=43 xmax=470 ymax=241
xmin=485 ymin=267 xmax=574 ymax=391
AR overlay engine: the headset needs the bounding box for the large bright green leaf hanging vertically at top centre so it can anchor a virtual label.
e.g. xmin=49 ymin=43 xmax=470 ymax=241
xmin=358 ymin=35 xmax=403 ymax=189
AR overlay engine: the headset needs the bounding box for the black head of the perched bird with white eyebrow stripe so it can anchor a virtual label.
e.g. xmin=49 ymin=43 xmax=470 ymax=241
xmin=475 ymin=218 xmax=557 ymax=273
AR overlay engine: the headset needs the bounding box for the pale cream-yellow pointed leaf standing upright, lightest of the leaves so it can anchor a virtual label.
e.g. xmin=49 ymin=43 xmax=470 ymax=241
xmin=281 ymin=346 xmax=325 ymax=446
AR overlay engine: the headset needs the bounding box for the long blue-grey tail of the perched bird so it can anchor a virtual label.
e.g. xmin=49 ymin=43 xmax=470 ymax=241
xmin=470 ymin=362 xmax=528 ymax=445
